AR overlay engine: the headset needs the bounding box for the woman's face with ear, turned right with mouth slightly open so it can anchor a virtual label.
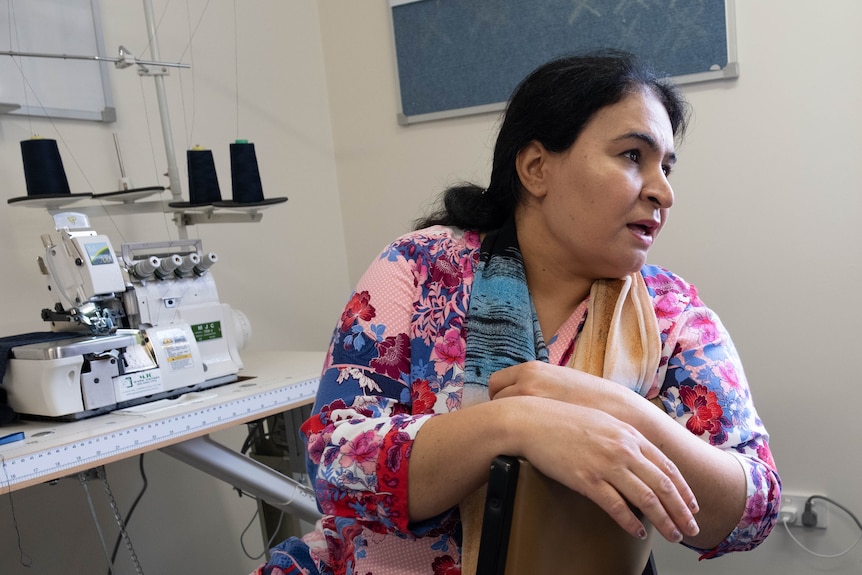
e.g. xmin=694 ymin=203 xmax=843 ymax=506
xmin=519 ymin=89 xmax=676 ymax=280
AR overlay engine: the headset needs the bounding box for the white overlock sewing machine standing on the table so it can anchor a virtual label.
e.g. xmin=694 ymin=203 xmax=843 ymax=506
xmin=2 ymin=223 xmax=250 ymax=419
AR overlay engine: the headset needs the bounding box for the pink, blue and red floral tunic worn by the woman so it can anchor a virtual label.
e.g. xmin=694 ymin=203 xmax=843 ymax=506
xmin=302 ymin=226 xmax=780 ymax=575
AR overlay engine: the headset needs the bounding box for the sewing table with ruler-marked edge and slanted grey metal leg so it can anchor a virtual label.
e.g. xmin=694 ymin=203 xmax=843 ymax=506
xmin=0 ymin=351 xmax=324 ymax=519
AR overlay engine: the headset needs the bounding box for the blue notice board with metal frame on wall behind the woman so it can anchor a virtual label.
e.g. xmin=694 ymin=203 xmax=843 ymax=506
xmin=389 ymin=0 xmax=739 ymax=125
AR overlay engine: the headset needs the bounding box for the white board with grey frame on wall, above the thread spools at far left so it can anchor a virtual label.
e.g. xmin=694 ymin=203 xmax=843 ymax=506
xmin=0 ymin=0 xmax=116 ymax=122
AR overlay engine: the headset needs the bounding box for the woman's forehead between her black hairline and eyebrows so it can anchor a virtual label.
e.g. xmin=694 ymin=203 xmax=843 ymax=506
xmin=578 ymin=89 xmax=674 ymax=153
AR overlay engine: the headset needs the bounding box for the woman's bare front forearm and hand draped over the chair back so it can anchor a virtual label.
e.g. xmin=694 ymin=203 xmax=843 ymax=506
xmin=409 ymin=394 xmax=699 ymax=542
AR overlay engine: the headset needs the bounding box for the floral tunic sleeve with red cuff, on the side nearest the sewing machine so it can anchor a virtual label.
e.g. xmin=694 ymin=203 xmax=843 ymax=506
xmin=302 ymin=231 xmax=478 ymax=533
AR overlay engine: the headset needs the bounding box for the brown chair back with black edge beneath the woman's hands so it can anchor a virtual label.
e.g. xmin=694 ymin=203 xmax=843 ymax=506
xmin=476 ymin=456 xmax=656 ymax=575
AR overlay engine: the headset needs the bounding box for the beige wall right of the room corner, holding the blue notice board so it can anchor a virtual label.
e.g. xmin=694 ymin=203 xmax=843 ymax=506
xmin=320 ymin=0 xmax=862 ymax=575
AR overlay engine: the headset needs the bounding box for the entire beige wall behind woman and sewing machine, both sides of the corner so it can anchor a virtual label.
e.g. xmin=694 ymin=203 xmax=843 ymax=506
xmin=0 ymin=0 xmax=862 ymax=575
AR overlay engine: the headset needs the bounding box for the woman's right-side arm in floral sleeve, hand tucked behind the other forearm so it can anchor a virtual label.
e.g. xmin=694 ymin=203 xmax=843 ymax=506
xmin=489 ymin=288 xmax=781 ymax=557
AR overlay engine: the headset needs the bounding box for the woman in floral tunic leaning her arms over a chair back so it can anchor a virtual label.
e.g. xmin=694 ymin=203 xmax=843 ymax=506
xmin=258 ymin=53 xmax=780 ymax=575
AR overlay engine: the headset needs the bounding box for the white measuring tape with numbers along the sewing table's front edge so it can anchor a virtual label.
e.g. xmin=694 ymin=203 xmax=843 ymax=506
xmin=0 ymin=378 xmax=320 ymax=491
